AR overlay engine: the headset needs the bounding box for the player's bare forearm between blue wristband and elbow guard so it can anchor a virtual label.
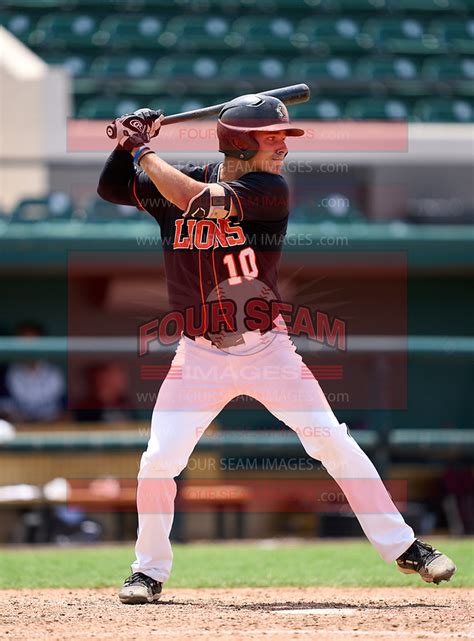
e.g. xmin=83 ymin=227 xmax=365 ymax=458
xmin=136 ymin=154 xmax=203 ymax=211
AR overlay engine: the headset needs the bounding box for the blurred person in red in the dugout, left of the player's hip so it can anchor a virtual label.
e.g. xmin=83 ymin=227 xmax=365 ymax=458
xmin=77 ymin=361 xmax=133 ymax=423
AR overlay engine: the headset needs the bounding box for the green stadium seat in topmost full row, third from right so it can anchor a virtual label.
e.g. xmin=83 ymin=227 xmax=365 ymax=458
xmin=294 ymin=16 xmax=371 ymax=54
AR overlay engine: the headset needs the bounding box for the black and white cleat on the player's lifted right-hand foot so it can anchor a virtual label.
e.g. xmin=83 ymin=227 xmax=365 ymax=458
xmin=397 ymin=539 xmax=456 ymax=584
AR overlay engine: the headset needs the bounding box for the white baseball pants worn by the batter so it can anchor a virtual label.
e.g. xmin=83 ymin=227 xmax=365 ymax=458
xmin=132 ymin=331 xmax=415 ymax=582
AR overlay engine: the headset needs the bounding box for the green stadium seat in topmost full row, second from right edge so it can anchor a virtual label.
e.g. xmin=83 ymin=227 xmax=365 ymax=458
xmin=364 ymin=18 xmax=444 ymax=55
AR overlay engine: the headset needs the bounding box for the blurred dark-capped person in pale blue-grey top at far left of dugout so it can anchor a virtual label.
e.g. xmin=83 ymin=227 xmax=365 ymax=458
xmin=0 ymin=322 xmax=66 ymax=422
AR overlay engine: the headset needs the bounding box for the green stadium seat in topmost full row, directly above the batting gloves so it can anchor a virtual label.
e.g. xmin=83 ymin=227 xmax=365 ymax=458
xmin=97 ymin=14 xmax=167 ymax=50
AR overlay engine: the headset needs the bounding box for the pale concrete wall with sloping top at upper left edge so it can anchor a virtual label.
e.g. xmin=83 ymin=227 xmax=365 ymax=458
xmin=0 ymin=27 xmax=70 ymax=209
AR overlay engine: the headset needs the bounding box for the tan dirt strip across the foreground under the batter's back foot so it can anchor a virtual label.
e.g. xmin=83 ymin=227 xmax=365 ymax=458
xmin=0 ymin=586 xmax=474 ymax=641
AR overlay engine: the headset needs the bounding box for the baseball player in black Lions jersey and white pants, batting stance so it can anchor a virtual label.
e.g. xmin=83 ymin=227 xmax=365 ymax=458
xmin=98 ymin=94 xmax=456 ymax=604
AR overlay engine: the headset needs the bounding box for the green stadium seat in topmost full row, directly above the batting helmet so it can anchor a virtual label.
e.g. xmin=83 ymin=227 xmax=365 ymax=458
xmin=228 ymin=15 xmax=295 ymax=53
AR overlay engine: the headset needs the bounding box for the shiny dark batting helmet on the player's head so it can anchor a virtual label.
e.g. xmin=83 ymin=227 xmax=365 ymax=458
xmin=217 ymin=94 xmax=304 ymax=160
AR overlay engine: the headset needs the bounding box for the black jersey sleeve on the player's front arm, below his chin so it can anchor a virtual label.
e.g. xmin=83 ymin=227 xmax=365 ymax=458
xmin=220 ymin=172 xmax=289 ymax=221
